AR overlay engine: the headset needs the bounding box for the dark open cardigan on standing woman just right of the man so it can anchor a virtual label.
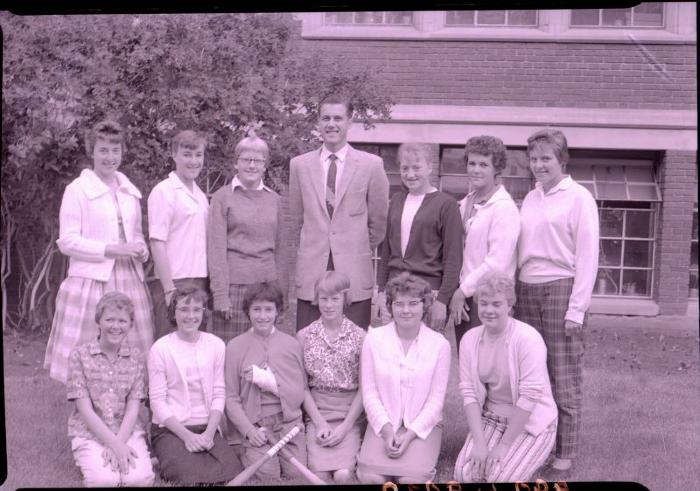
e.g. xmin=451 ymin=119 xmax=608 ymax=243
xmin=377 ymin=191 xmax=464 ymax=305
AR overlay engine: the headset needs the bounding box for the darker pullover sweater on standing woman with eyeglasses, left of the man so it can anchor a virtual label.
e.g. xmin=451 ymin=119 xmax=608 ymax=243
xmin=207 ymin=185 xmax=281 ymax=310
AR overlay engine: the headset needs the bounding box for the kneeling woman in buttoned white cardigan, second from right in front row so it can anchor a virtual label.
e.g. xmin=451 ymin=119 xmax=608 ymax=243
xmin=357 ymin=272 xmax=450 ymax=484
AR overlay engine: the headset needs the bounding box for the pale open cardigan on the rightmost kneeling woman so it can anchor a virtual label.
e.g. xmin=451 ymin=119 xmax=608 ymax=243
xmin=459 ymin=318 xmax=557 ymax=436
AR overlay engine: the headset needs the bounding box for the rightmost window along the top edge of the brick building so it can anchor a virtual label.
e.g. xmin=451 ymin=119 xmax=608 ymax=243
xmin=571 ymin=2 xmax=664 ymax=28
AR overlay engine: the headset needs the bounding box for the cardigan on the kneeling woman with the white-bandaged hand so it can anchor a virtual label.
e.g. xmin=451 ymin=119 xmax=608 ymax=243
xmin=224 ymin=328 xmax=307 ymax=443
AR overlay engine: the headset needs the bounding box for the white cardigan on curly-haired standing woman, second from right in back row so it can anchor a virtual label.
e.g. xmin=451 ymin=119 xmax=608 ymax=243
xmin=459 ymin=185 xmax=520 ymax=297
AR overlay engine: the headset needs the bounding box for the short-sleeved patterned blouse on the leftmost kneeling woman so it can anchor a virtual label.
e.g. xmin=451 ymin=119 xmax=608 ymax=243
xmin=67 ymin=340 xmax=146 ymax=440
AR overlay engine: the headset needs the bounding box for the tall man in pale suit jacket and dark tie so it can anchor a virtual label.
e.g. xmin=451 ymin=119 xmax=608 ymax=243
xmin=289 ymin=94 xmax=389 ymax=330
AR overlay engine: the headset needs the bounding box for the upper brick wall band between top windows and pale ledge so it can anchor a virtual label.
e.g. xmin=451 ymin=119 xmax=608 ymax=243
xmin=301 ymin=39 xmax=697 ymax=109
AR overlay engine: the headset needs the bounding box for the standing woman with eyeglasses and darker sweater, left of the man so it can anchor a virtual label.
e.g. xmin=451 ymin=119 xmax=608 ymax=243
xmin=207 ymin=133 xmax=280 ymax=343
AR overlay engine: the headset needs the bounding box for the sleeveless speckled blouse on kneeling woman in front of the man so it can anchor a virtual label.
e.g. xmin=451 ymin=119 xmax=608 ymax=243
xmin=303 ymin=317 xmax=365 ymax=392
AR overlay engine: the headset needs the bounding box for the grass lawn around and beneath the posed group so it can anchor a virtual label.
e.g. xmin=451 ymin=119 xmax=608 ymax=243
xmin=1 ymin=316 xmax=700 ymax=491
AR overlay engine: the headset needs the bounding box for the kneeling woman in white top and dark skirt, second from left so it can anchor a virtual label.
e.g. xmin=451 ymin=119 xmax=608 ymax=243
xmin=148 ymin=287 xmax=242 ymax=484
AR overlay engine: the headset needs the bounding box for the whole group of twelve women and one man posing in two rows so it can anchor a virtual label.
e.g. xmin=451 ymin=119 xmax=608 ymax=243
xmin=45 ymin=94 xmax=599 ymax=486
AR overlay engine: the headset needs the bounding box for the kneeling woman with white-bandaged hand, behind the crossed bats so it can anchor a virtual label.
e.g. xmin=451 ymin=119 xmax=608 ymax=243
xmin=226 ymin=282 xmax=306 ymax=480
